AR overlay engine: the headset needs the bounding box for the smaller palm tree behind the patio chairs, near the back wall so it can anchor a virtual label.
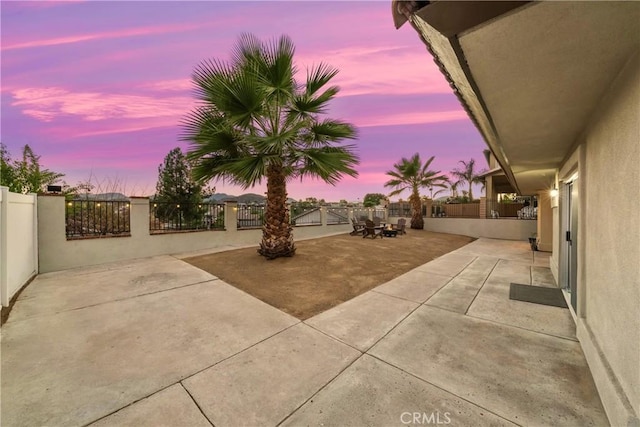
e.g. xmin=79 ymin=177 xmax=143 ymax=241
xmin=384 ymin=153 xmax=448 ymax=230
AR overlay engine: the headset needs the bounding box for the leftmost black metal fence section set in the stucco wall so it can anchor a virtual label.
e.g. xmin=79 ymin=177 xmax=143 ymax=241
xmin=65 ymin=200 xmax=131 ymax=240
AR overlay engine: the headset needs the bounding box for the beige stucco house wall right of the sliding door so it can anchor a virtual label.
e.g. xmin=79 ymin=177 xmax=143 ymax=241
xmin=578 ymin=52 xmax=640 ymax=425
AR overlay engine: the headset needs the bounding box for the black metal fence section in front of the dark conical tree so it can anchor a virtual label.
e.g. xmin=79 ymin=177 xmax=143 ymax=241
xmin=149 ymin=202 xmax=224 ymax=234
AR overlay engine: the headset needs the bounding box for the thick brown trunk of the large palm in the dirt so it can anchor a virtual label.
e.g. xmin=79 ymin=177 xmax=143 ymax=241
xmin=258 ymin=165 xmax=296 ymax=260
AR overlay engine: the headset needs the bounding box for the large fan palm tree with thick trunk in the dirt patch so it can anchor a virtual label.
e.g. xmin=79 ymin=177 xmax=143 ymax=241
xmin=183 ymin=34 xmax=358 ymax=259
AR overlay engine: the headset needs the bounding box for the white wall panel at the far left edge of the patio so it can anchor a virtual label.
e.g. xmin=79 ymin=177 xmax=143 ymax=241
xmin=0 ymin=187 xmax=38 ymax=307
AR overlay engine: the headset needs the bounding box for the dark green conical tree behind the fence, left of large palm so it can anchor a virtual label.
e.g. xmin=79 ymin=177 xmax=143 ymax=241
xmin=154 ymin=147 xmax=202 ymax=222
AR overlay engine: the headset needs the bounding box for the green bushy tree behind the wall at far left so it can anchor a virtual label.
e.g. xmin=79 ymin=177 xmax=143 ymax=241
xmin=0 ymin=143 xmax=64 ymax=194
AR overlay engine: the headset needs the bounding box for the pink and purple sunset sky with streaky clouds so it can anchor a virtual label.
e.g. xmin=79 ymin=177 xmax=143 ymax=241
xmin=0 ymin=1 xmax=487 ymax=201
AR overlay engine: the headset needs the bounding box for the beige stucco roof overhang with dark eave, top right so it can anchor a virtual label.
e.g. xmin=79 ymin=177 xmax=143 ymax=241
xmin=394 ymin=1 xmax=640 ymax=194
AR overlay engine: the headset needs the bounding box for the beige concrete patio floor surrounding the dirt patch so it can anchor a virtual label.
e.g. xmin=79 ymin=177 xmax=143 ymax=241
xmin=1 ymin=239 xmax=608 ymax=426
